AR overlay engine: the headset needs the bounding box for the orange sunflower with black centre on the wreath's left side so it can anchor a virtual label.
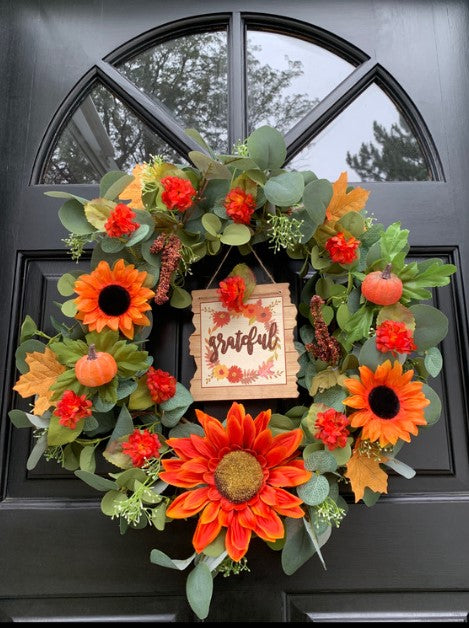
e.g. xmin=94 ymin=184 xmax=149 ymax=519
xmin=75 ymin=259 xmax=155 ymax=339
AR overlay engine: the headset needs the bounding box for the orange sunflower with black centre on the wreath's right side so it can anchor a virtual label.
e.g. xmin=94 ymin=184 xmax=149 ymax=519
xmin=344 ymin=360 xmax=430 ymax=447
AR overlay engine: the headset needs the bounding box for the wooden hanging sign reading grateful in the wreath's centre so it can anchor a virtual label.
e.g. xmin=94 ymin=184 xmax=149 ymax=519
xmin=189 ymin=283 xmax=299 ymax=401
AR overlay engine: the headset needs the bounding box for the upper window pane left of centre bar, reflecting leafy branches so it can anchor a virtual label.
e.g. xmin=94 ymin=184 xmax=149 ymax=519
xmin=119 ymin=31 xmax=228 ymax=152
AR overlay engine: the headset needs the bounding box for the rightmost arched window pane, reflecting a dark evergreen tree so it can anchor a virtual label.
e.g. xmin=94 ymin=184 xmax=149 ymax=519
xmin=288 ymin=85 xmax=432 ymax=181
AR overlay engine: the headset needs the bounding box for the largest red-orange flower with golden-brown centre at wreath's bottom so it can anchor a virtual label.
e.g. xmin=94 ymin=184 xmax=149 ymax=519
xmin=160 ymin=403 xmax=311 ymax=561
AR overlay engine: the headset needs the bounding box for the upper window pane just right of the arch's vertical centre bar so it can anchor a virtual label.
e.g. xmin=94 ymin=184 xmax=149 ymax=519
xmin=246 ymin=30 xmax=354 ymax=133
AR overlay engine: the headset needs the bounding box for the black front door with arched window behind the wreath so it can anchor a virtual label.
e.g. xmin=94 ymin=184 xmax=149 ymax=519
xmin=0 ymin=0 xmax=469 ymax=622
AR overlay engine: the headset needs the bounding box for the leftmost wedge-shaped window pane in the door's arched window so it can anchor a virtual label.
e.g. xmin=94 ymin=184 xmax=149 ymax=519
xmin=42 ymin=85 xmax=182 ymax=184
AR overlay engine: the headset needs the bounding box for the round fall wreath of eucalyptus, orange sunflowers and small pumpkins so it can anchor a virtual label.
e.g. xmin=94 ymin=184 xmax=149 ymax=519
xmin=9 ymin=126 xmax=456 ymax=619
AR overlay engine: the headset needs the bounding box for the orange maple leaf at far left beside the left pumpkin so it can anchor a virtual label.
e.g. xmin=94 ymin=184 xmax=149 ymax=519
xmin=13 ymin=347 xmax=65 ymax=416
